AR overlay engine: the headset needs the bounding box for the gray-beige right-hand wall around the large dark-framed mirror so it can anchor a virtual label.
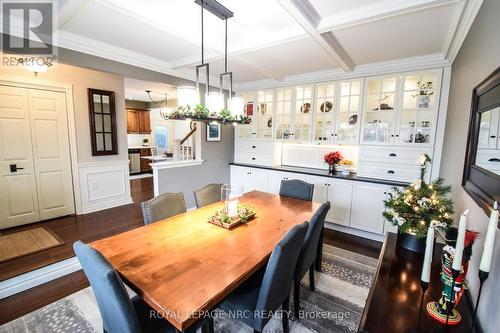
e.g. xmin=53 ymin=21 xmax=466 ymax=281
xmin=440 ymin=0 xmax=500 ymax=332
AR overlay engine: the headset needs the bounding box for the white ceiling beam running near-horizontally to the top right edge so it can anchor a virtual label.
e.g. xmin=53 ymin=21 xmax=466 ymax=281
xmin=318 ymin=0 xmax=458 ymax=33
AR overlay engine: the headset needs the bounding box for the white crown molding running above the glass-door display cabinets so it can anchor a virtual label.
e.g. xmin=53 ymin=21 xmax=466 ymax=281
xmin=235 ymin=53 xmax=451 ymax=92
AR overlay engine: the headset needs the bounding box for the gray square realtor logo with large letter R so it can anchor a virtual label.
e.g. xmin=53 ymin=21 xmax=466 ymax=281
xmin=2 ymin=1 xmax=54 ymax=55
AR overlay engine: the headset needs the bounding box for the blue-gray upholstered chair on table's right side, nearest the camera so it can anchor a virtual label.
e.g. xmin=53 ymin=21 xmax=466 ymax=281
xmin=215 ymin=222 xmax=308 ymax=333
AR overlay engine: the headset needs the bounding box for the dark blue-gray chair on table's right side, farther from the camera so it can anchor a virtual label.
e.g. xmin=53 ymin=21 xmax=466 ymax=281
xmin=293 ymin=201 xmax=330 ymax=319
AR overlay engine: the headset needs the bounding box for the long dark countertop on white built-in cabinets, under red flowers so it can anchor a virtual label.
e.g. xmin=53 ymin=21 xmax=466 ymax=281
xmin=229 ymin=162 xmax=409 ymax=187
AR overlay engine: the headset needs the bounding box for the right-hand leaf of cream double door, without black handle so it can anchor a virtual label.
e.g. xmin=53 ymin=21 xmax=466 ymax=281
xmin=28 ymin=89 xmax=75 ymax=220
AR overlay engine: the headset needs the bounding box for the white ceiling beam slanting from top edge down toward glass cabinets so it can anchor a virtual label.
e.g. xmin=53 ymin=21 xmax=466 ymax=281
xmin=278 ymin=0 xmax=354 ymax=72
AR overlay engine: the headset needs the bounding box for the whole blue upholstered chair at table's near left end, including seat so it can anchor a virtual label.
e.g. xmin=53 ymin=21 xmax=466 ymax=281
xmin=73 ymin=241 xmax=208 ymax=333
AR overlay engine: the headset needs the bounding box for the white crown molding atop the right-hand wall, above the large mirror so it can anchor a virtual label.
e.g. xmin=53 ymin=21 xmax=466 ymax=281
xmin=443 ymin=0 xmax=483 ymax=63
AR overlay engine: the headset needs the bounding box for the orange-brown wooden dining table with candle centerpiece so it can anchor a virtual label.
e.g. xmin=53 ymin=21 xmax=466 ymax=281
xmin=90 ymin=191 xmax=319 ymax=331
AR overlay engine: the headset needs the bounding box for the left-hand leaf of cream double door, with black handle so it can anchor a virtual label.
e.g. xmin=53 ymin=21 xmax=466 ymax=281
xmin=0 ymin=86 xmax=40 ymax=229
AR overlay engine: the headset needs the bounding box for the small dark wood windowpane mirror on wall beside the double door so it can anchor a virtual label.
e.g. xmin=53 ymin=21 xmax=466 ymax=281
xmin=88 ymin=88 xmax=118 ymax=156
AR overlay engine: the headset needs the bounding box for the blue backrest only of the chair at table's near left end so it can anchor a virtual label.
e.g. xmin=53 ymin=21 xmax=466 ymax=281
xmin=73 ymin=241 xmax=141 ymax=333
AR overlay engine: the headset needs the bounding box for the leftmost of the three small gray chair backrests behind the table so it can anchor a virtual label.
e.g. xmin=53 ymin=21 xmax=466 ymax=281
xmin=141 ymin=193 xmax=186 ymax=224
